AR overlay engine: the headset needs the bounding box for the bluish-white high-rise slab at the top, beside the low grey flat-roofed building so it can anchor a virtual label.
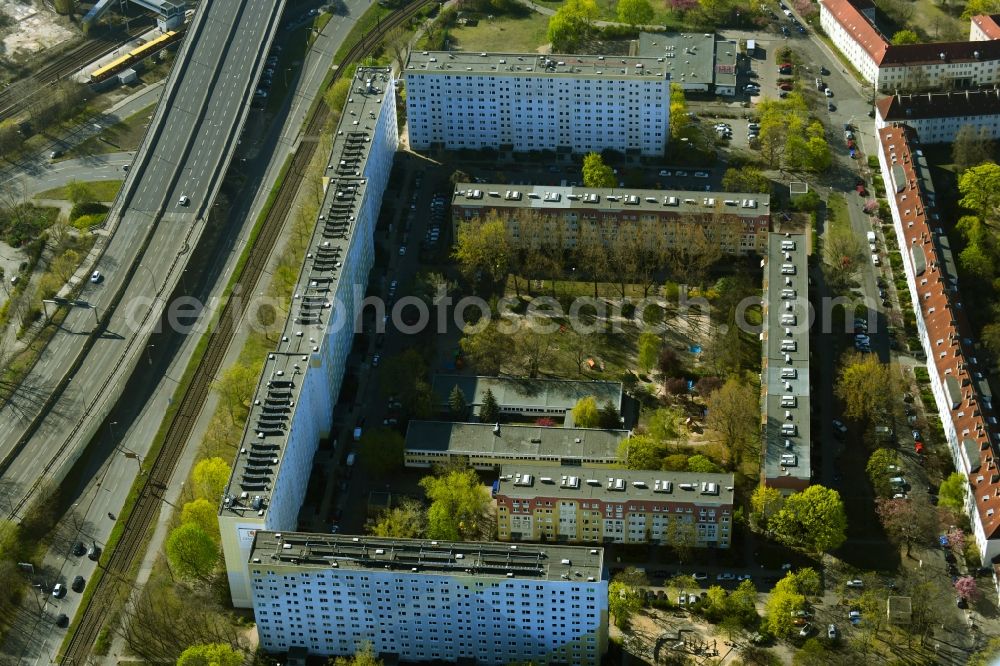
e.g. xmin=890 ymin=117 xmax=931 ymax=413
xmin=405 ymin=51 xmax=670 ymax=156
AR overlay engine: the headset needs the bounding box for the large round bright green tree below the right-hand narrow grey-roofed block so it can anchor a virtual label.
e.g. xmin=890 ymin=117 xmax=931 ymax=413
xmin=769 ymin=486 xmax=847 ymax=553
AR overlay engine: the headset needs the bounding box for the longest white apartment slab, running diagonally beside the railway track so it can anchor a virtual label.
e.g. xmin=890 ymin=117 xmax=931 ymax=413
xmin=219 ymin=67 xmax=399 ymax=608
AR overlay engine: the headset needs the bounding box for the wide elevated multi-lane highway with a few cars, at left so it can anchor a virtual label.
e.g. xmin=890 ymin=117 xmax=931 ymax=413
xmin=0 ymin=0 xmax=284 ymax=510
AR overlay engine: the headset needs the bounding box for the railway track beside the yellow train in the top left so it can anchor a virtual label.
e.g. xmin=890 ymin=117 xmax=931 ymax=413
xmin=0 ymin=16 xmax=152 ymax=121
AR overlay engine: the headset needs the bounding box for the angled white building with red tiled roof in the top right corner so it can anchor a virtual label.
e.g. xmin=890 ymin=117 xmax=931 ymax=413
xmin=820 ymin=0 xmax=1000 ymax=92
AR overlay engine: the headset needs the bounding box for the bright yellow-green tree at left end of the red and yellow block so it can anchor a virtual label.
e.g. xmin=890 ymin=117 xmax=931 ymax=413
xmin=420 ymin=469 xmax=490 ymax=541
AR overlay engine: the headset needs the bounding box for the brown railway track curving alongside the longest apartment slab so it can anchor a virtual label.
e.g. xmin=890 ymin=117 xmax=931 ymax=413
xmin=60 ymin=0 xmax=434 ymax=665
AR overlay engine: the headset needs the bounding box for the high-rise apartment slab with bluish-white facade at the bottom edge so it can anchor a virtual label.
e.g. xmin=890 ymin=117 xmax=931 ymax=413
xmin=249 ymin=532 xmax=608 ymax=666
